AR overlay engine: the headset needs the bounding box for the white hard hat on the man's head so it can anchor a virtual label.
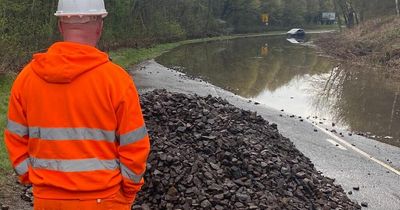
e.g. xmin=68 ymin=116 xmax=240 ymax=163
xmin=54 ymin=0 xmax=108 ymax=17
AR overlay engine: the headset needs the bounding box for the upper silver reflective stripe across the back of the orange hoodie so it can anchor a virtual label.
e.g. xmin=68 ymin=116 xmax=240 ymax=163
xmin=29 ymin=127 xmax=116 ymax=142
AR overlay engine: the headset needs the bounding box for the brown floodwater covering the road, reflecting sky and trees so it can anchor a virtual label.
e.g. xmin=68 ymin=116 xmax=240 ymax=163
xmin=156 ymin=36 xmax=400 ymax=147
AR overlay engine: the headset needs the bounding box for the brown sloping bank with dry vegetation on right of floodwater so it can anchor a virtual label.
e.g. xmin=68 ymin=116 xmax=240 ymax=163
xmin=316 ymin=17 xmax=400 ymax=79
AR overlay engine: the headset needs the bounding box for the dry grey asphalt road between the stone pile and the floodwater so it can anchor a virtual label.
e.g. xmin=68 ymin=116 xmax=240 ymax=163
xmin=131 ymin=60 xmax=400 ymax=210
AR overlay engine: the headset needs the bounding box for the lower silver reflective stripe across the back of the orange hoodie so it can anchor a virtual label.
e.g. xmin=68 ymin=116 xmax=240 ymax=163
xmin=31 ymin=158 xmax=119 ymax=172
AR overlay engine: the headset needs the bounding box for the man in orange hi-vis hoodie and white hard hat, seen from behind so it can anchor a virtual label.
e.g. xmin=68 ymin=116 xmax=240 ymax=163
xmin=5 ymin=0 xmax=150 ymax=210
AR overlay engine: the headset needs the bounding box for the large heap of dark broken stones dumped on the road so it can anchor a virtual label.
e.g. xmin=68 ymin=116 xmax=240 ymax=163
xmin=134 ymin=91 xmax=360 ymax=209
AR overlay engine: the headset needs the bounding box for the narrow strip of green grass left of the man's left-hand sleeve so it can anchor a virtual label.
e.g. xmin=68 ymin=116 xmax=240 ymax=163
xmin=0 ymin=74 xmax=15 ymax=178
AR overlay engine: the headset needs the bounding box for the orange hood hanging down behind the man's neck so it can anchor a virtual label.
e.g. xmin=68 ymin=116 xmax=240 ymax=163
xmin=31 ymin=42 xmax=109 ymax=83
